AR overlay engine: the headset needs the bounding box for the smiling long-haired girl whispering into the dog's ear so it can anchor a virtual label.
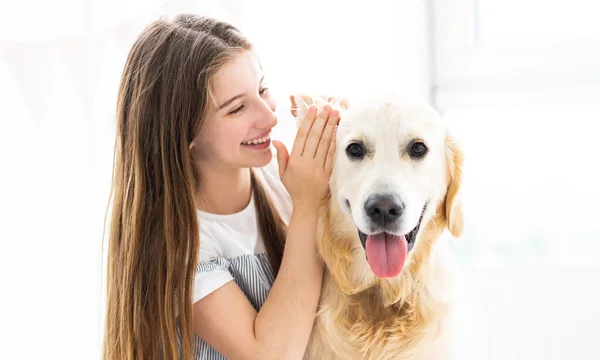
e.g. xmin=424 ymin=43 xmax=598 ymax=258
xmin=103 ymin=15 xmax=339 ymax=360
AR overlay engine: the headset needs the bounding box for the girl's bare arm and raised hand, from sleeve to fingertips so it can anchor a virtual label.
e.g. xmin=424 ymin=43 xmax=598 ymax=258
xmin=194 ymin=106 xmax=339 ymax=360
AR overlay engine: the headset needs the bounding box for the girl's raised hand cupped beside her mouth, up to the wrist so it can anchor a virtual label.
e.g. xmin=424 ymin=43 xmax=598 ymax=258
xmin=273 ymin=105 xmax=340 ymax=211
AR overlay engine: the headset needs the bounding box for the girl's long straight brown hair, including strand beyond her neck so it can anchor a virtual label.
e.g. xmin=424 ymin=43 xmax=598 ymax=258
xmin=103 ymin=14 xmax=285 ymax=360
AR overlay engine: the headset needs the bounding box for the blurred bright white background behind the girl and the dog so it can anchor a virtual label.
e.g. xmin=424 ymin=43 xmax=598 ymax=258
xmin=0 ymin=0 xmax=600 ymax=360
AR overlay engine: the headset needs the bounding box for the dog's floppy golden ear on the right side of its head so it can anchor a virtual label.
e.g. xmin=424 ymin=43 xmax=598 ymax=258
xmin=445 ymin=133 xmax=464 ymax=237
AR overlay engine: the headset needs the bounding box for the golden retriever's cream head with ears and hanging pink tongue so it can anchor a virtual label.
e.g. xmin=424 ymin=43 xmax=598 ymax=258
xmin=293 ymin=95 xmax=462 ymax=278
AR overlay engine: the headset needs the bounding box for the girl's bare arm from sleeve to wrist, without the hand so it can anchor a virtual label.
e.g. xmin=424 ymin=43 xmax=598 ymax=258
xmin=194 ymin=208 xmax=323 ymax=360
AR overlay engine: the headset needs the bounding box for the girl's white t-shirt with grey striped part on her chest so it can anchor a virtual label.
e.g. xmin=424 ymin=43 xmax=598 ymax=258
xmin=193 ymin=156 xmax=292 ymax=311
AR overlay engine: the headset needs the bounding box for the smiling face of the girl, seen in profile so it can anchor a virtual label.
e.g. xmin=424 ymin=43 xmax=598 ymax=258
xmin=190 ymin=51 xmax=277 ymax=173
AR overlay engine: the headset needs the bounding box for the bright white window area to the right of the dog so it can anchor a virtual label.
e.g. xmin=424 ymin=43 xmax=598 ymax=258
xmin=431 ymin=0 xmax=600 ymax=360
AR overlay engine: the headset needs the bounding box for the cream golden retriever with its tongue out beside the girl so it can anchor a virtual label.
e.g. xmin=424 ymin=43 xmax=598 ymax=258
xmin=290 ymin=94 xmax=463 ymax=360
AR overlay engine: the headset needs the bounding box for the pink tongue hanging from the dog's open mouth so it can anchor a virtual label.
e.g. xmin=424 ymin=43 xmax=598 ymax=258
xmin=366 ymin=233 xmax=408 ymax=278
